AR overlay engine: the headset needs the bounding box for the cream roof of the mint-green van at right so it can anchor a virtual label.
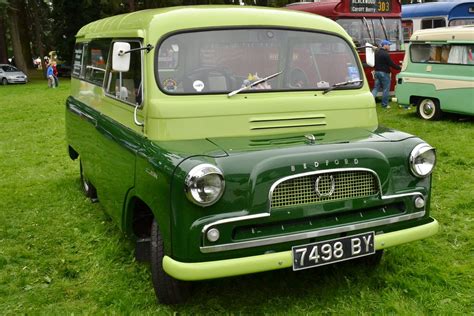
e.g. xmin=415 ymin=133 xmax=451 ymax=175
xmin=410 ymin=25 xmax=474 ymax=42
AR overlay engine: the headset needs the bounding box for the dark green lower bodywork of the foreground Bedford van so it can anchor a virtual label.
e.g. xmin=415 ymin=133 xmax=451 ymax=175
xmin=66 ymin=97 xmax=431 ymax=262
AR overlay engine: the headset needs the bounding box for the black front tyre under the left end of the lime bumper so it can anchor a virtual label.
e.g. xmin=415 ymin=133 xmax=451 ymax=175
xmin=150 ymin=220 xmax=191 ymax=305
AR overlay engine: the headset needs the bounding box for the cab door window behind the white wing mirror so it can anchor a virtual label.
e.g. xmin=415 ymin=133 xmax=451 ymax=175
xmin=105 ymin=41 xmax=143 ymax=105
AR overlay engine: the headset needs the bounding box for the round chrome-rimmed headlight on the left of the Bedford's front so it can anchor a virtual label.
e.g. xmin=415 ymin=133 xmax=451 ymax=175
xmin=184 ymin=164 xmax=225 ymax=206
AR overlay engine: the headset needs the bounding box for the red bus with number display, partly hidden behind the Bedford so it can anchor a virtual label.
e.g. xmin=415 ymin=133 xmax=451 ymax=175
xmin=287 ymin=0 xmax=405 ymax=93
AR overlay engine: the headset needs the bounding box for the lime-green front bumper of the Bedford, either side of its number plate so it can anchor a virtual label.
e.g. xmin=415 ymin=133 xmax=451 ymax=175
xmin=163 ymin=219 xmax=439 ymax=281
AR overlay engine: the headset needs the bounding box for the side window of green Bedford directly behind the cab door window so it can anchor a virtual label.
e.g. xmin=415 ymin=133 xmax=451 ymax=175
xmin=82 ymin=39 xmax=111 ymax=86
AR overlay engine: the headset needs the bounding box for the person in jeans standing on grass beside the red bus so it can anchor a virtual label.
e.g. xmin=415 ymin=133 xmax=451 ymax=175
xmin=372 ymin=40 xmax=401 ymax=109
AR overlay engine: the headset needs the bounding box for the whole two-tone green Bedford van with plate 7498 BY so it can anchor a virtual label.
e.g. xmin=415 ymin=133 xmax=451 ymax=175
xmin=66 ymin=6 xmax=438 ymax=303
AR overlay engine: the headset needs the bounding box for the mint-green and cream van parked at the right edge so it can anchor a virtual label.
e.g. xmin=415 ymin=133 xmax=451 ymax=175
xmin=395 ymin=25 xmax=474 ymax=120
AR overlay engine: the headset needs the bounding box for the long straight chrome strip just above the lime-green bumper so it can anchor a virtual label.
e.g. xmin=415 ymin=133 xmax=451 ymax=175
xmin=200 ymin=210 xmax=425 ymax=253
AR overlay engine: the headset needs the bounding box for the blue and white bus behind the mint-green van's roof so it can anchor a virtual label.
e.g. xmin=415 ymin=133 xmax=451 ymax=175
xmin=402 ymin=0 xmax=474 ymax=42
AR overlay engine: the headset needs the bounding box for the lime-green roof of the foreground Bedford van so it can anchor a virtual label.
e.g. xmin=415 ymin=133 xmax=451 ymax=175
xmin=76 ymin=5 xmax=350 ymax=41
